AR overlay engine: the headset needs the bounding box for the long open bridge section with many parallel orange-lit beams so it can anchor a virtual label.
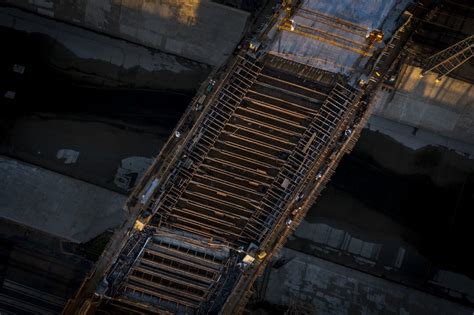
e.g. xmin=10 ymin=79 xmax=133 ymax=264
xmin=153 ymin=58 xmax=331 ymax=248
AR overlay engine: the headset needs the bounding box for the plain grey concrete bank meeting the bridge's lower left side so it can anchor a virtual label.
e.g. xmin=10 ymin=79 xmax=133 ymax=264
xmin=0 ymin=156 xmax=126 ymax=243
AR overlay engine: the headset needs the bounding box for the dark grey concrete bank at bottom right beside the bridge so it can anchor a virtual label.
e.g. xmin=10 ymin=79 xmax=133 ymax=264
xmin=264 ymin=248 xmax=473 ymax=315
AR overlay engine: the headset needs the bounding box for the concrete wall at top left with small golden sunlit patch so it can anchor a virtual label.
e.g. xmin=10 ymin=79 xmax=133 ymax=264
xmin=0 ymin=0 xmax=249 ymax=66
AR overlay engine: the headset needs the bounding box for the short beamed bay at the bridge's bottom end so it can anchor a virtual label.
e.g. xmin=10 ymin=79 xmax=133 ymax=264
xmin=116 ymin=230 xmax=229 ymax=314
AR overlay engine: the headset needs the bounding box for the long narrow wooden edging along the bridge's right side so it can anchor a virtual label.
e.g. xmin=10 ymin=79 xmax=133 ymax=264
xmin=222 ymin=11 xmax=416 ymax=314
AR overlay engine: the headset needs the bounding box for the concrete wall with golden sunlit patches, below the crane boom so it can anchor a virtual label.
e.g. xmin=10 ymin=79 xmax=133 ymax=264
xmin=374 ymin=66 xmax=474 ymax=144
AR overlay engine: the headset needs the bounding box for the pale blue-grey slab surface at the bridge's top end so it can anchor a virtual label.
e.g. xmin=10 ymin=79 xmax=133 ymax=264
xmin=270 ymin=0 xmax=409 ymax=74
